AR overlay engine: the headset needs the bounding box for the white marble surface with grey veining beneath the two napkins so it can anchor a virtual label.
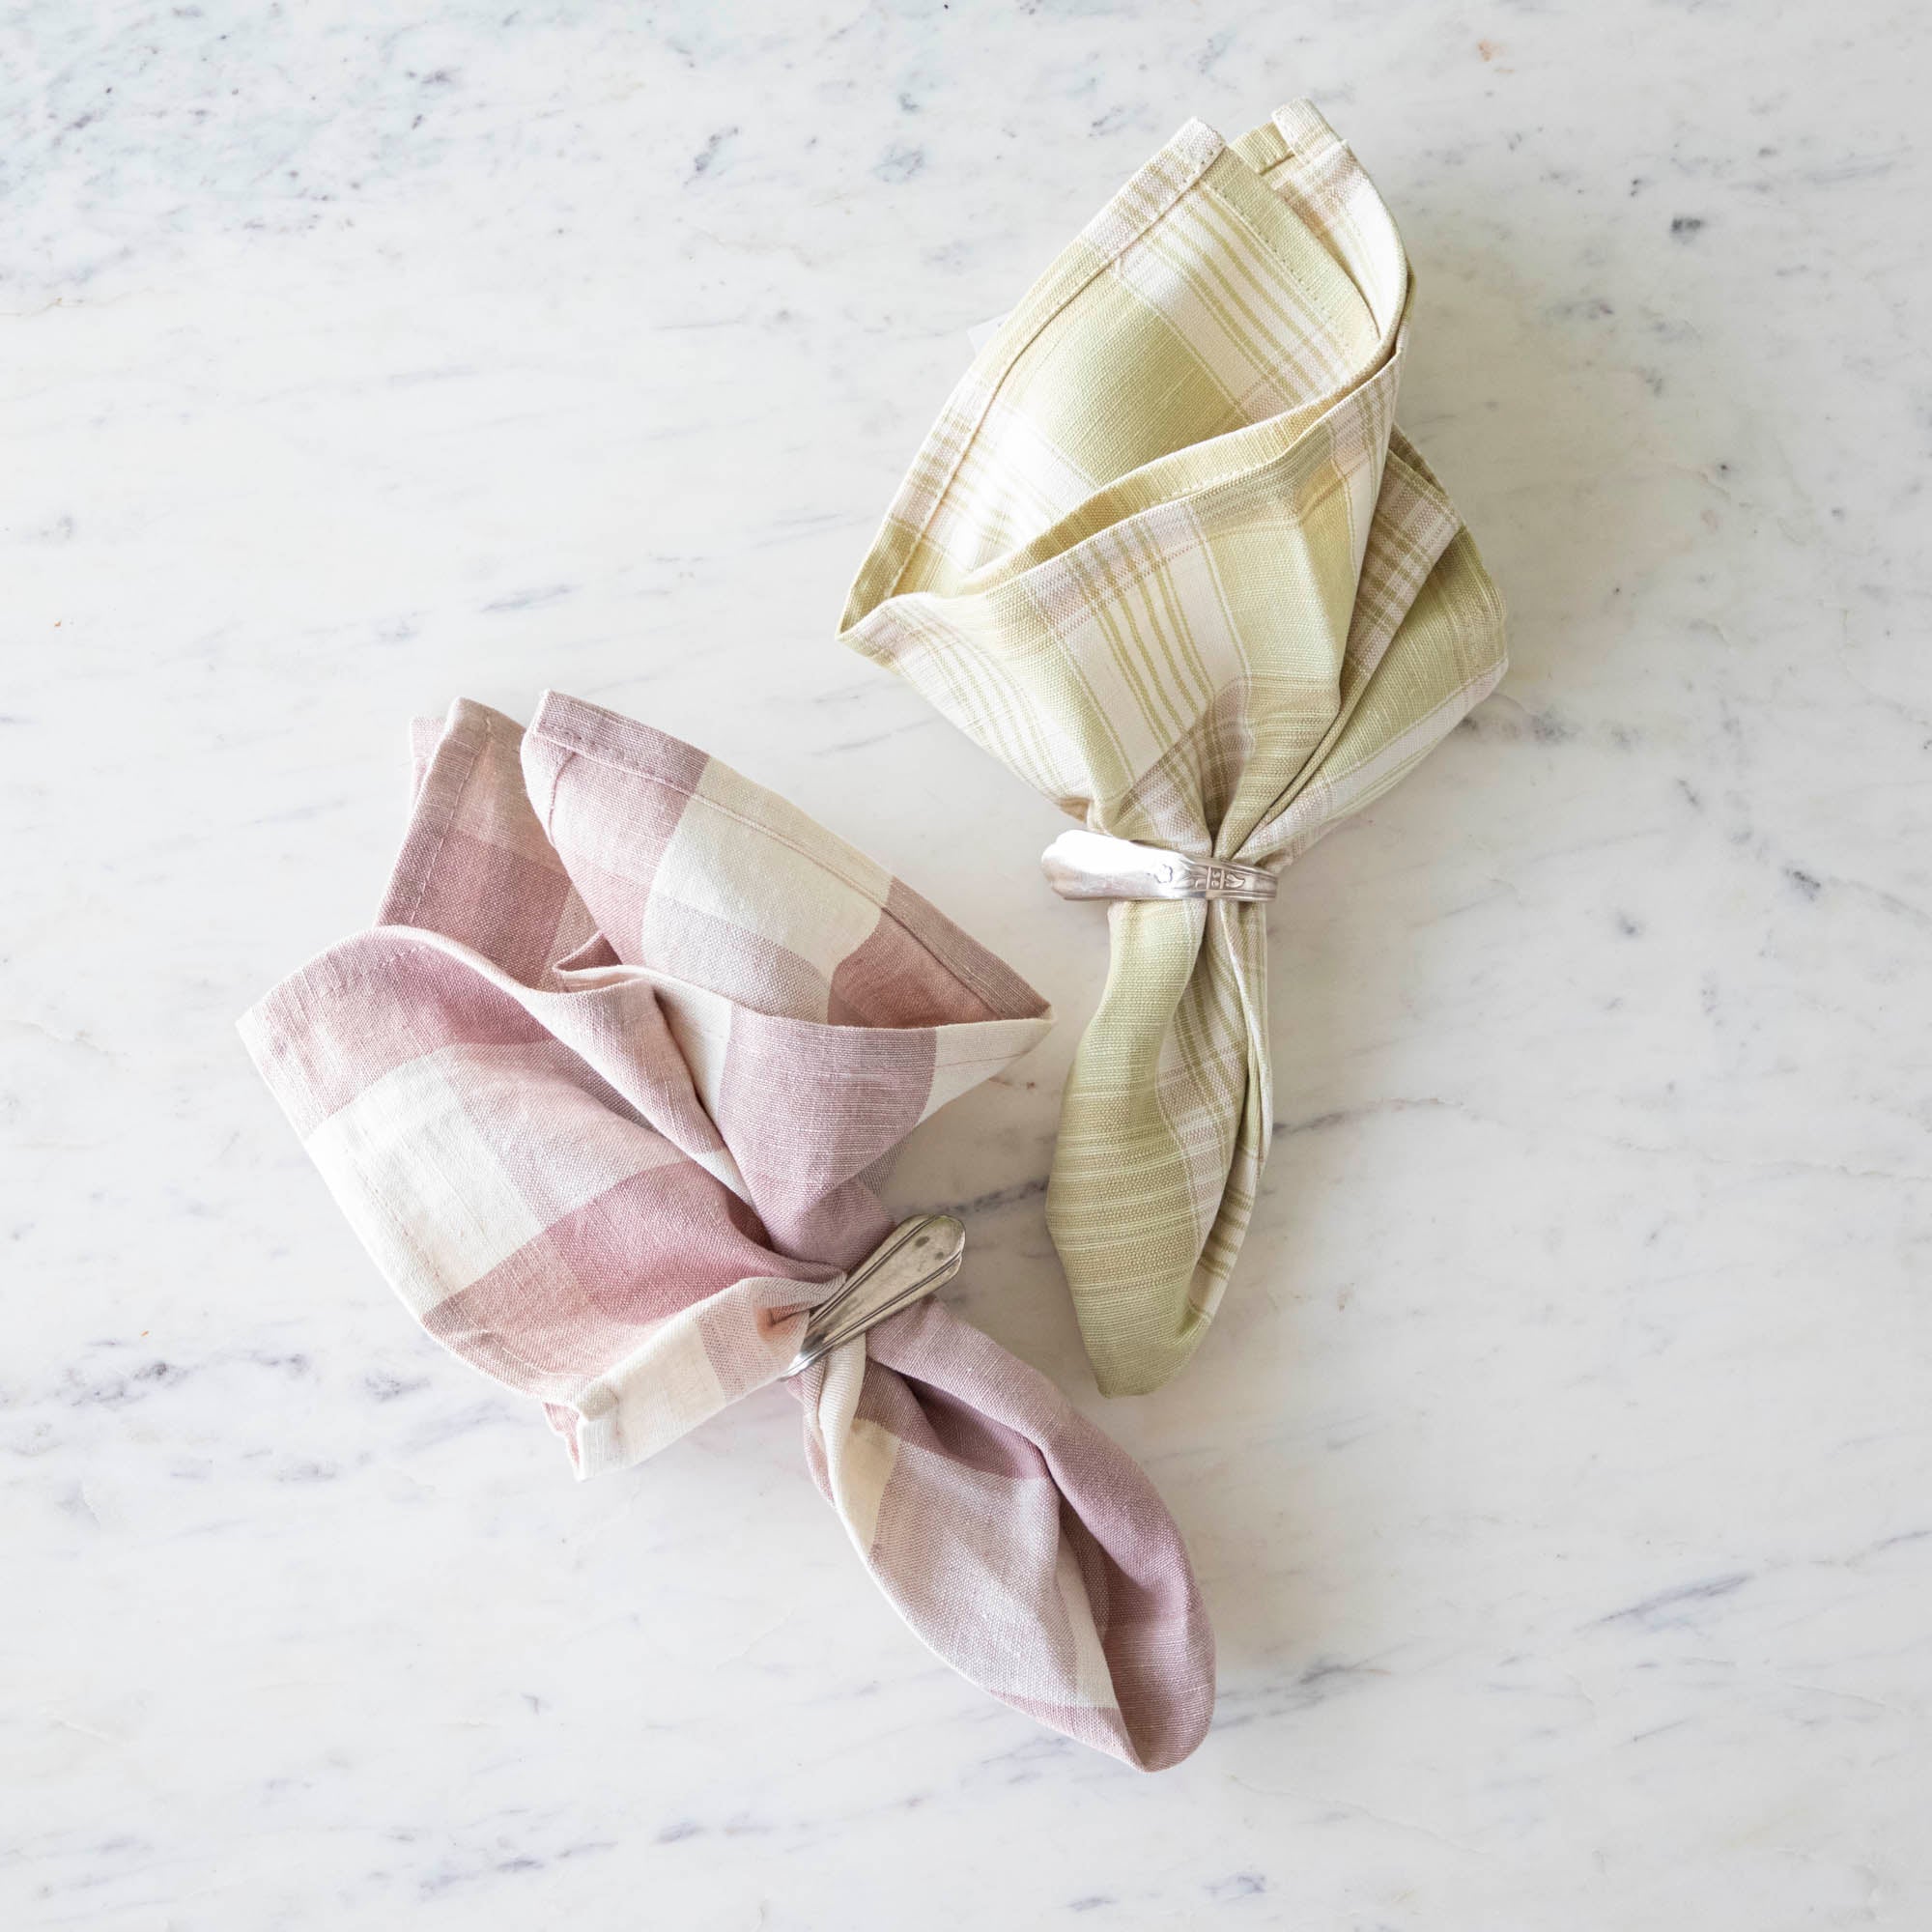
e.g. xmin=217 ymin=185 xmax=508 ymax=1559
xmin=0 ymin=0 xmax=1932 ymax=1932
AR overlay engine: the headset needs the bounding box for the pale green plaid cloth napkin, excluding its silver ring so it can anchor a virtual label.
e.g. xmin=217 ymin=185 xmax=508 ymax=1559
xmin=842 ymin=102 xmax=1505 ymax=1395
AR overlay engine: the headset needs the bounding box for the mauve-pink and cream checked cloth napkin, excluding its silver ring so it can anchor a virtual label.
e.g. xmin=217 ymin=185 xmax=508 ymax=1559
xmin=242 ymin=696 xmax=1213 ymax=1770
